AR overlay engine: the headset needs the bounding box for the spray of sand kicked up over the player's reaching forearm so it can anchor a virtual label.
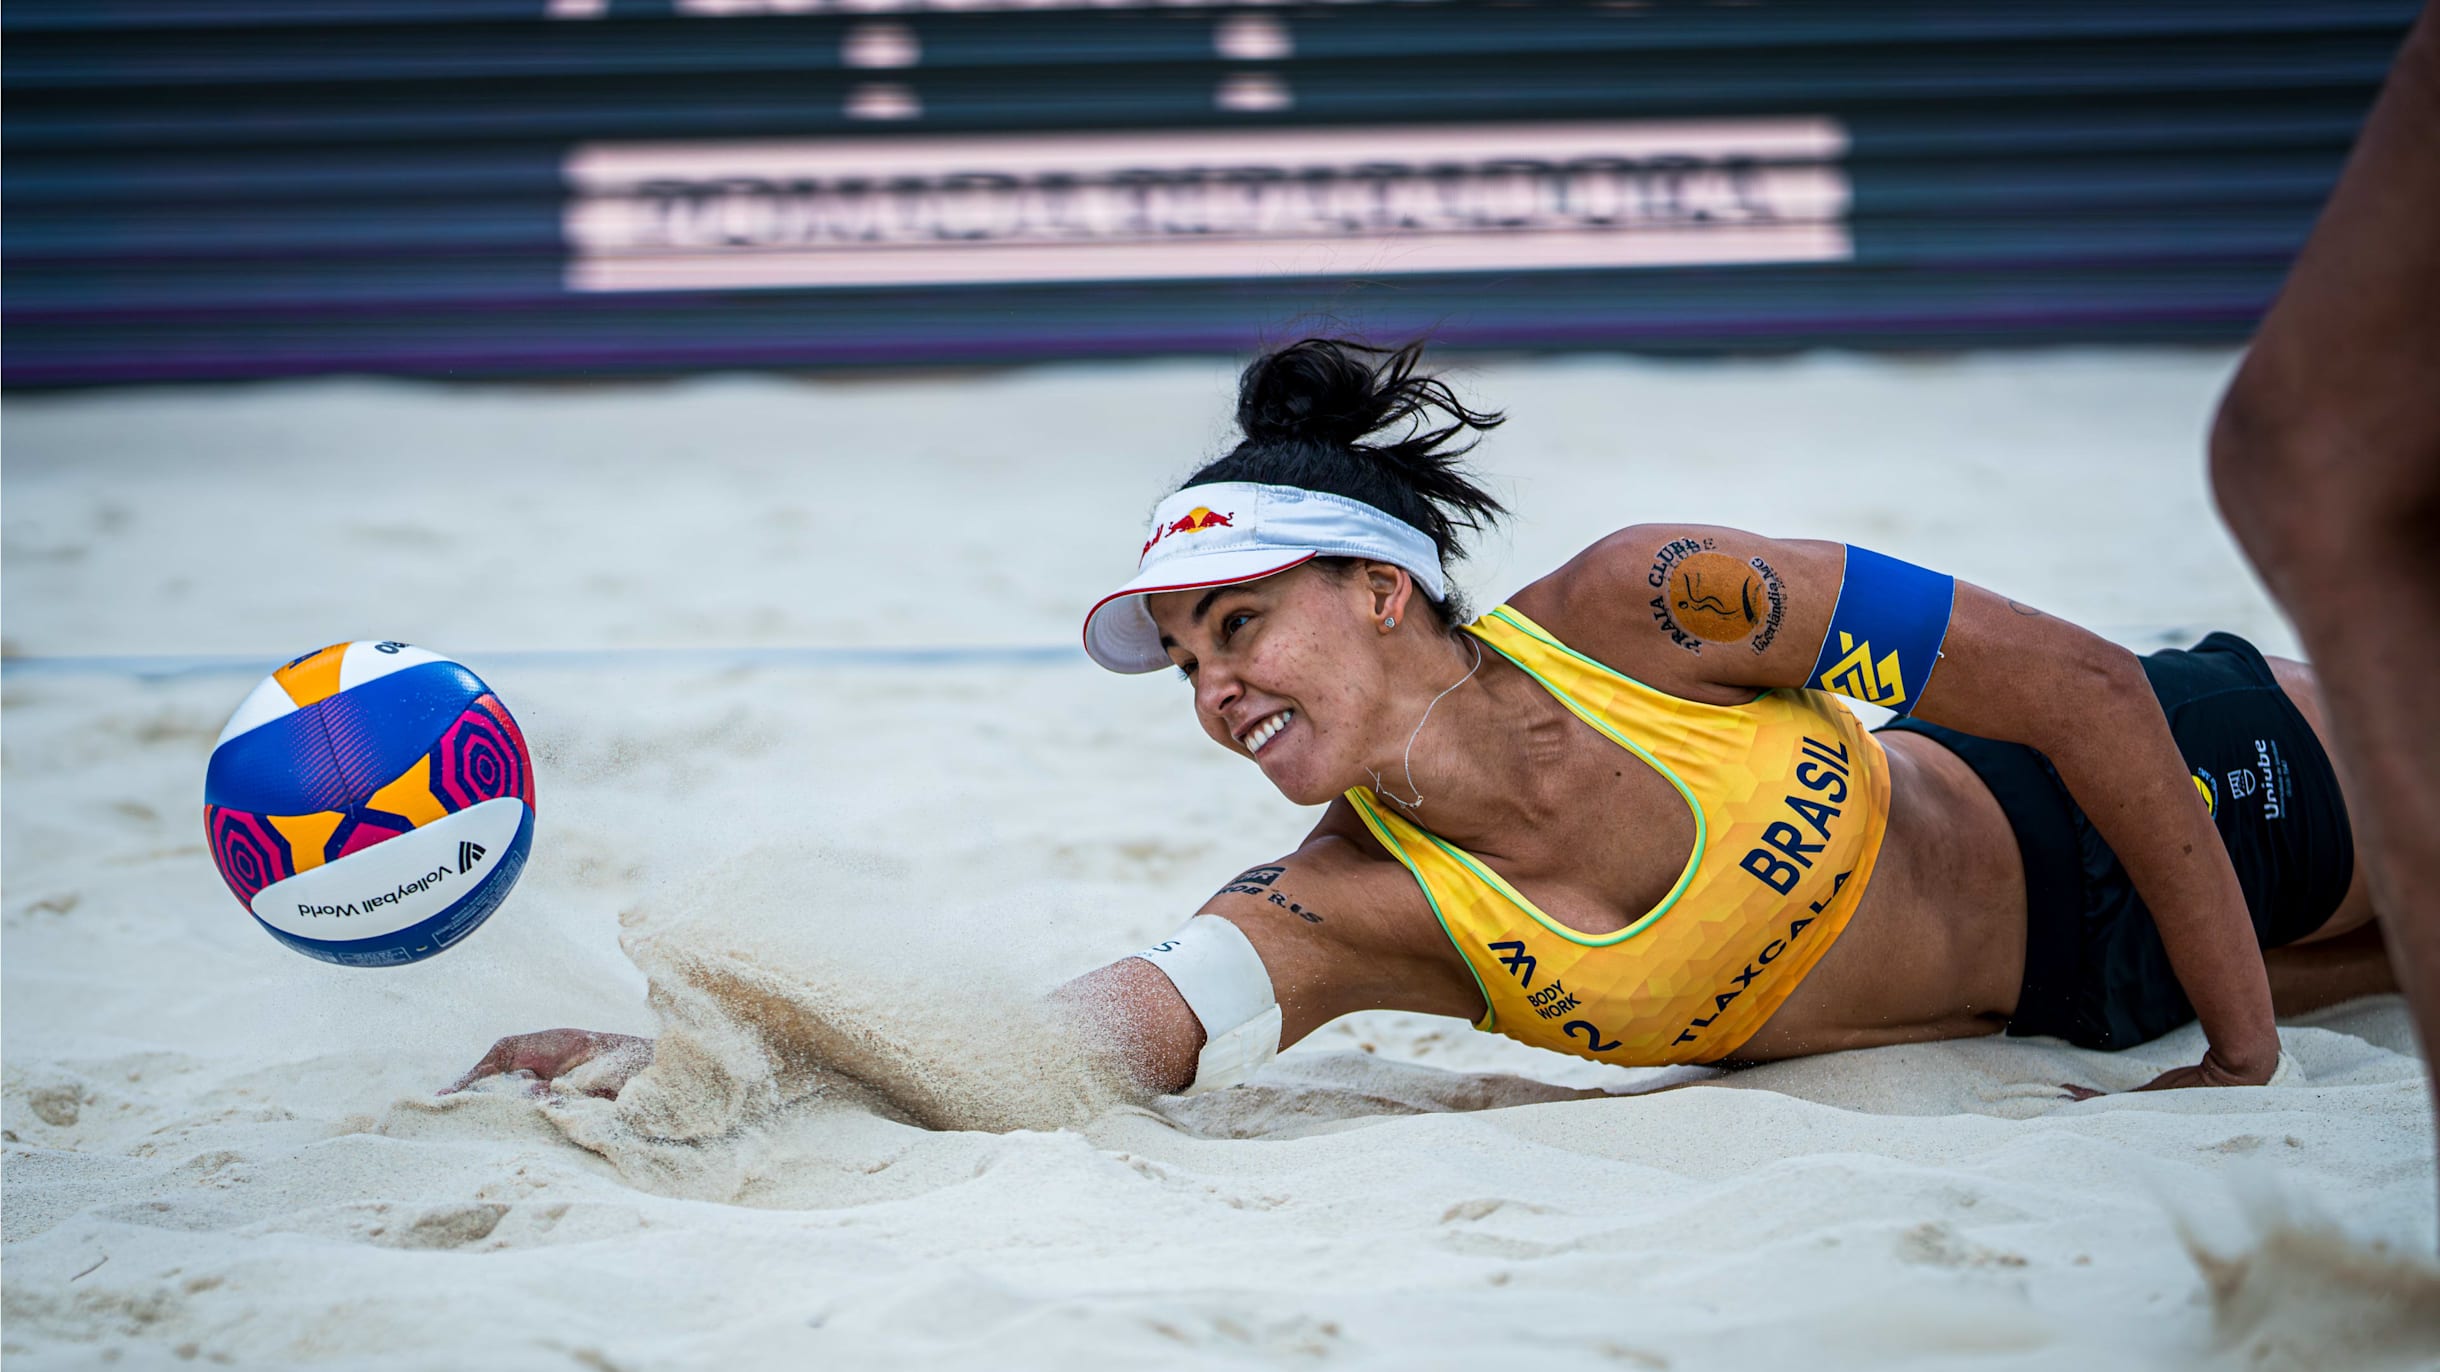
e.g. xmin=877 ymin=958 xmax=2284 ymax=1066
xmin=531 ymin=842 xmax=1149 ymax=1199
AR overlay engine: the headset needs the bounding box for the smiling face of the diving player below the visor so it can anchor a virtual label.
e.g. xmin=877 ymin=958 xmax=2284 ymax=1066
xmin=1147 ymin=564 xmax=1388 ymax=806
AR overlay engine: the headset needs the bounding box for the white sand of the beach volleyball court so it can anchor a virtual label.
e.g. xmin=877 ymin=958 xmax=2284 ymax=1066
xmin=0 ymin=352 xmax=2440 ymax=1372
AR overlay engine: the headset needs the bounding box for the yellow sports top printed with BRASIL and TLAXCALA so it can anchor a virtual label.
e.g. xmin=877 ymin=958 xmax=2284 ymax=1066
xmin=1347 ymin=605 xmax=1889 ymax=1067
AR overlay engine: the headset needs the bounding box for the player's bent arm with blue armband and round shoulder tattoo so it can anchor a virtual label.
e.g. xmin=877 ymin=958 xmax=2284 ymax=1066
xmin=1566 ymin=525 xmax=2279 ymax=1086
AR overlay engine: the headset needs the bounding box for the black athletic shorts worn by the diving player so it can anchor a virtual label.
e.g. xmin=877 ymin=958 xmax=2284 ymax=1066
xmin=1886 ymin=635 xmax=2355 ymax=1050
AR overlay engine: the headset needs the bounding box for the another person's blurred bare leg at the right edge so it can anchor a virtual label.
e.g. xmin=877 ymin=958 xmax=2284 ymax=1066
xmin=2211 ymin=0 xmax=2440 ymax=1176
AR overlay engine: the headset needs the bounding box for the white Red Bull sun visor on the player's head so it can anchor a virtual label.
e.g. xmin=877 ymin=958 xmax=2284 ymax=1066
xmin=1083 ymin=481 xmax=1449 ymax=671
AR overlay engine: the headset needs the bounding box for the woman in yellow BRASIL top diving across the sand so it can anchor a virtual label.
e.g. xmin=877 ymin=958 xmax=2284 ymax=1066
xmin=461 ymin=339 xmax=2386 ymax=1091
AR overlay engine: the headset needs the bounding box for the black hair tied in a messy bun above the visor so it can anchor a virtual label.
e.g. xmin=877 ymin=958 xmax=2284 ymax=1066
xmin=1186 ymin=337 xmax=1508 ymax=625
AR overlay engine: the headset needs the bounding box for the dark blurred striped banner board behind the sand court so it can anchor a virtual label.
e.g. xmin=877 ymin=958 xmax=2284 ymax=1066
xmin=0 ymin=0 xmax=2416 ymax=386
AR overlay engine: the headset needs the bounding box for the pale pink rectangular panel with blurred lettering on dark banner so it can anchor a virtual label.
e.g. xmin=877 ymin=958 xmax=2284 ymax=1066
xmin=564 ymin=117 xmax=1852 ymax=291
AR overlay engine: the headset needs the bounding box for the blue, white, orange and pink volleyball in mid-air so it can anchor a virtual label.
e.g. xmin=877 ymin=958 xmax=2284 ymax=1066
xmin=203 ymin=642 xmax=534 ymax=967
